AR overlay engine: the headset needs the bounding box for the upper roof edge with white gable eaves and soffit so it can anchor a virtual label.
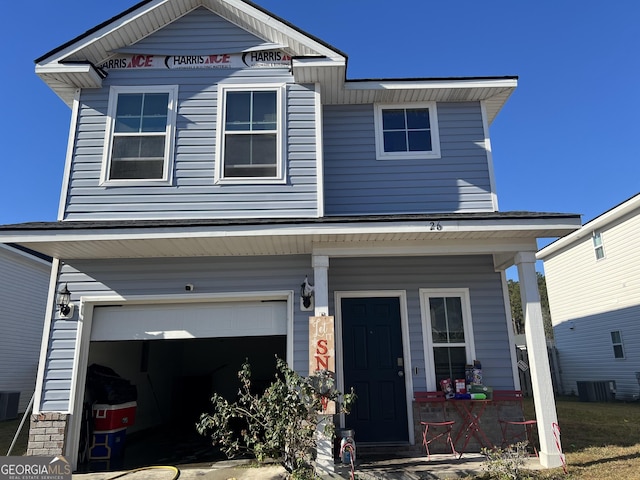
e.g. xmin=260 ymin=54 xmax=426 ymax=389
xmin=35 ymin=0 xmax=517 ymax=123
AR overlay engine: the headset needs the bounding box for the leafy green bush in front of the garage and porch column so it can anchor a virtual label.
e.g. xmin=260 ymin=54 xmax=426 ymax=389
xmin=196 ymin=358 xmax=355 ymax=474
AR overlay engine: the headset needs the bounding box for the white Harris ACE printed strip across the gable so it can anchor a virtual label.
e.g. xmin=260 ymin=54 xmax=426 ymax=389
xmin=100 ymin=50 xmax=291 ymax=70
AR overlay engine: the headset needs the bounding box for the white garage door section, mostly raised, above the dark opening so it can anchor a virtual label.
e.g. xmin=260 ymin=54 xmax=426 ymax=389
xmin=91 ymin=301 xmax=287 ymax=341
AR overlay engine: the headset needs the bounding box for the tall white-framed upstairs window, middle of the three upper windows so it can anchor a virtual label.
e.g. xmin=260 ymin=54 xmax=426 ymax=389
xmin=216 ymin=84 xmax=285 ymax=183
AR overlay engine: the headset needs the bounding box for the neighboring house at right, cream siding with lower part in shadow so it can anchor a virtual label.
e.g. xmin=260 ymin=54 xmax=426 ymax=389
xmin=538 ymin=194 xmax=640 ymax=400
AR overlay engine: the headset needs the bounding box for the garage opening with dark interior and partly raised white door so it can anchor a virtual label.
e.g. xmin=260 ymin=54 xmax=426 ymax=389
xmin=78 ymin=302 xmax=287 ymax=472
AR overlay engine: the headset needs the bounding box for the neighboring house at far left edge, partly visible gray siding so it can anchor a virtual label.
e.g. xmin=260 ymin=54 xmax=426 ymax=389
xmin=0 ymin=243 xmax=51 ymax=420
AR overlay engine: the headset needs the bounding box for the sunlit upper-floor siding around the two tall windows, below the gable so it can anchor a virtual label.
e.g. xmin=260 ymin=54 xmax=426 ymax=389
xmin=64 ymin=9 xmax=318 ymax=220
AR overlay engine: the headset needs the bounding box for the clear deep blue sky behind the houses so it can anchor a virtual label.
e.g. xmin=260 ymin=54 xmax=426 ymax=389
xmin=0 ymin=0 xmax=640 ymax=240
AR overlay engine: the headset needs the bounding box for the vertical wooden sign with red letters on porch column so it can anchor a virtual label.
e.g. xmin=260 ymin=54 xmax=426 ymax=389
xmin=309 ymin=315 xmax=336 ymax=415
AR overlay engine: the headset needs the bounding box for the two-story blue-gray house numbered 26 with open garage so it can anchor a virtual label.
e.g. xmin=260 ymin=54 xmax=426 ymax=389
xmin=0 ymin=0 xmax=580 ymax=472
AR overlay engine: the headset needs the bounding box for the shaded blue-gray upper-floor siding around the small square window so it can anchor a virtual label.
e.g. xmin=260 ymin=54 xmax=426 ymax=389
xmin=324 ymin=103 xmax=493 ymax=215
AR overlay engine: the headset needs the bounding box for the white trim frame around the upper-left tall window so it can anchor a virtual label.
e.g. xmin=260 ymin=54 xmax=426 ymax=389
xmin=100 ymin=85 xmax=178 ymax=186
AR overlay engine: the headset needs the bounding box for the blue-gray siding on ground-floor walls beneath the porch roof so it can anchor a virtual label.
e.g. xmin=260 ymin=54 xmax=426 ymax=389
xmin=41 ymin=255 xmax=513 ymax=411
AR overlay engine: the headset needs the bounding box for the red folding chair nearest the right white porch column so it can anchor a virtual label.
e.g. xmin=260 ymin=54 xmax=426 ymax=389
xmin=493 ymin=390 xmax=538 ymax=457
